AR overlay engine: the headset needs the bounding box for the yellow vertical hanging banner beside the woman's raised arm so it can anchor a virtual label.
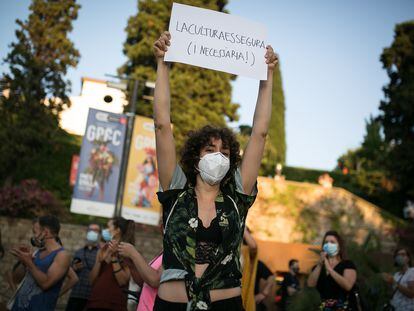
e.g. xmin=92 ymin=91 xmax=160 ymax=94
xmin=122 ymin=116 xmax=160 ymax=225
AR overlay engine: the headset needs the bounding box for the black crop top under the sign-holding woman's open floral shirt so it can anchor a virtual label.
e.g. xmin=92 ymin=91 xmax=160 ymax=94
xmin=195 ymin=217 xmax=222 ymax=265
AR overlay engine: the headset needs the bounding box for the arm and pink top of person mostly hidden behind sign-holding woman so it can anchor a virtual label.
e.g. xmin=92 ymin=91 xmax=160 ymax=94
xmin=118 ymin=242 xmax=162 ymax=311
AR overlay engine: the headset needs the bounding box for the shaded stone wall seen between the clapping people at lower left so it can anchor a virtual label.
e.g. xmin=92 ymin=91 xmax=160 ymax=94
xmin=0 ymin=217 xmax=162 ymax=310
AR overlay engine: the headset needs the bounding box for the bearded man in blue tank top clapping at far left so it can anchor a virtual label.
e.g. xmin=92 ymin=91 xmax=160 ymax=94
xmin=11 ymin=216 xmax=71 ymax=311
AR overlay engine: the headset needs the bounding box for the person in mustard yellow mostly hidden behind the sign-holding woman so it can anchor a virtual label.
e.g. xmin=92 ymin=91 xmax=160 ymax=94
xmin=240 ymin=226 xmax=258 ymax=310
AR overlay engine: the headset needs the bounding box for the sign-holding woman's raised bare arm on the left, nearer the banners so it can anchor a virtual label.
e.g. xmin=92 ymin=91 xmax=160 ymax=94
xmin=154 ymin=31 xmax=177 ymax=190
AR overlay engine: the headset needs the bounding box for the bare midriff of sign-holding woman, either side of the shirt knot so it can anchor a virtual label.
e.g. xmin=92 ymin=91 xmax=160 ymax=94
xmin=158 ymin=281 xmax=241 ymax=303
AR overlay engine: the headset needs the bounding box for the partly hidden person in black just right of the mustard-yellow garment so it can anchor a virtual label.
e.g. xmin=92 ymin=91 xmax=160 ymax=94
xmin=254 ymin=260 xmax=274 ymax=311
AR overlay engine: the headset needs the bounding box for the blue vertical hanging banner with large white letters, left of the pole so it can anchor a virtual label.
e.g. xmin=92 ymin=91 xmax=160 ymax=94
xmin=70 ymin=109 xmax=127 ymax=218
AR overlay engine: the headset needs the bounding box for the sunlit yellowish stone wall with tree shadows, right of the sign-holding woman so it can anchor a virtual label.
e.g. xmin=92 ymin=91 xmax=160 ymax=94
xmin=247 ymin=177 xmax=402 ymax=252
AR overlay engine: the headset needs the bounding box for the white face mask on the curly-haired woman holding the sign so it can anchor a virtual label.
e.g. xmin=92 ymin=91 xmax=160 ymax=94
xmin=198 ymin=152 xmax=230 ymax=185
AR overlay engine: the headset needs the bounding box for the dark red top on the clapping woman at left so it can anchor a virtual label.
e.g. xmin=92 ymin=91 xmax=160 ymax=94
xmin=87 ymin=261 xmax=128 ymax=311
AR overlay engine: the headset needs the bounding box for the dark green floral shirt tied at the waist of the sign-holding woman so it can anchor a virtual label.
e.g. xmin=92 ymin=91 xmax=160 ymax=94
xmin=158 ymin=166 xmax=257 ymax=310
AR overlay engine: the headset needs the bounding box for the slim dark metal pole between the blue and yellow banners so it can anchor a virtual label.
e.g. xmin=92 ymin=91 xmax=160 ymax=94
xmin=115 ymin=79 xmax=139 ymax=216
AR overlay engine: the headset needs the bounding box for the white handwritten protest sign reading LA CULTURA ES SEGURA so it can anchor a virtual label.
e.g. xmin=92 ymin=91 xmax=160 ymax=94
xmin=164 ymin=3 xmax=267 ymax=80
